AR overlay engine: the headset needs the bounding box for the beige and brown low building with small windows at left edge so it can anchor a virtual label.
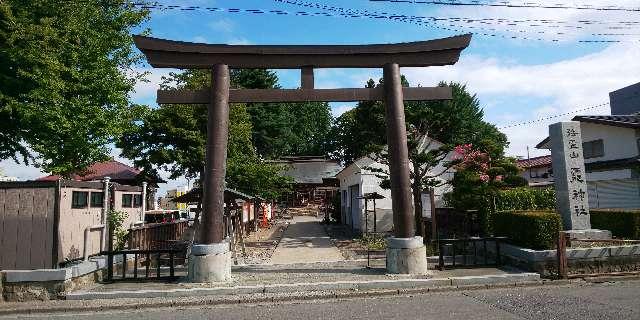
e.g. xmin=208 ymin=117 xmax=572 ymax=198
xmin=0 ymin=180 xmax=143 ymax=270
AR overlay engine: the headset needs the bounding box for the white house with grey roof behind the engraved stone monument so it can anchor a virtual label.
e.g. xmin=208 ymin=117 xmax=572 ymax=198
xmin=536 ymin=115 xmax=640 ymax=208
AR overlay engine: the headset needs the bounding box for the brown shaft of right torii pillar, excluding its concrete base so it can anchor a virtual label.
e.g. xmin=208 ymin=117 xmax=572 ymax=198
xmin=383 ymin=63 xmax=415 ymax=238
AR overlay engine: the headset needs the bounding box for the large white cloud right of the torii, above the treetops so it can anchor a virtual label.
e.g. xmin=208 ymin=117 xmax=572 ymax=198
xmin=402 ymin=43 xmax=640 ymax=155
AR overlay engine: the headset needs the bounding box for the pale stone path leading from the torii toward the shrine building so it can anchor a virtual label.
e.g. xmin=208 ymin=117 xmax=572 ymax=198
xmin=271 ymin=216 xmax=344 ymax=264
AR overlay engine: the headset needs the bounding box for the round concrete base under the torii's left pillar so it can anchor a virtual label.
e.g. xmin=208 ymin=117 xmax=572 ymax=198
xmin=188 ymin=241 xmax=231 ymax=283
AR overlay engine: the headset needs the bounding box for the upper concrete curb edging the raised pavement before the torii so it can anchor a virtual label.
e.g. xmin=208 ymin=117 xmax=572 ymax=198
xmin=66 ymin=273 xmax=540 ymax=300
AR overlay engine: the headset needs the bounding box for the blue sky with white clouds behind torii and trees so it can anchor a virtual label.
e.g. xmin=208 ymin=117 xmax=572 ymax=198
xmin=0 ymin=0 xmax=640 ymax=195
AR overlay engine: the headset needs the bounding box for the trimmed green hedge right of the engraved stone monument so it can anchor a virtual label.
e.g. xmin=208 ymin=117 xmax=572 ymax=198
xmin=590 ymin=210 xmax=640 ymax=239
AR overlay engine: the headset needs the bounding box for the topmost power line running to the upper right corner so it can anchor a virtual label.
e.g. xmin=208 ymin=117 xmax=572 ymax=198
xmin=369 ymin=0 xmax=640 ymax=12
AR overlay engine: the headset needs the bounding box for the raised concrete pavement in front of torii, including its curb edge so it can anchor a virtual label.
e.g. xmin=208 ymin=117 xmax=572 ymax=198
xmin=66 ymin=261 xmax=541 ymax=300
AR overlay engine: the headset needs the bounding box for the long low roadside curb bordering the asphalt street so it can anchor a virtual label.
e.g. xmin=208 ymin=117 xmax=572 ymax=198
xmin=0 ymin=280 xmax=572 ymax=316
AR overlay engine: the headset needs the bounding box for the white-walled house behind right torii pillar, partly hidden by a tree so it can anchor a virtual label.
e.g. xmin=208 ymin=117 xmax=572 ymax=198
xmin=336 ymin=138 xmax=453 ymax=233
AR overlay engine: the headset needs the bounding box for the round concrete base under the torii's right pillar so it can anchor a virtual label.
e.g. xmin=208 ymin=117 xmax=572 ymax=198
xmin=387 ymin=237 xmax=429 ymax=275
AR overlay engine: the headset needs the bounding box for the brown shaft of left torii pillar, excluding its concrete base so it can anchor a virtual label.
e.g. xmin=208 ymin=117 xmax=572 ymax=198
xmin=200 ymin=64 xmax=229 ymax=244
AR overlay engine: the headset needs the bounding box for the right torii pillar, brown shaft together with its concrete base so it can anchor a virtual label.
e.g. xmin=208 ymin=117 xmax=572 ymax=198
xmin=383 ymin=63 xmax=428 ymax=274
